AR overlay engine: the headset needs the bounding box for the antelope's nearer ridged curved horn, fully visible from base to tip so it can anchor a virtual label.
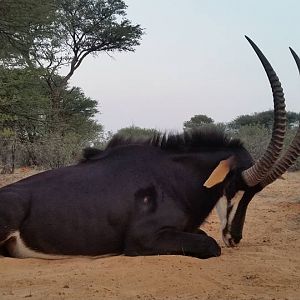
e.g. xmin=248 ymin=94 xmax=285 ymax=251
xmin=242 ymin=36 xmax=286 ymax=186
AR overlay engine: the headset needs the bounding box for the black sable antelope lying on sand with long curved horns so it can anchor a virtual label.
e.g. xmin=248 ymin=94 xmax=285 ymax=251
xmin=0 ymin=38 xmax=300 ymax=258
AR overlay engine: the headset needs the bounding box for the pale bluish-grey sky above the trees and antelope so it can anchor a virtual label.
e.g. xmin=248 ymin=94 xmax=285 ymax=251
xmin=70 ymin=0 xmax=300 ymax=132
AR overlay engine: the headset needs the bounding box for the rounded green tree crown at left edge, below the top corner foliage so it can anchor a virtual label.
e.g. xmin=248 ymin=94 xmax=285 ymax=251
xmin=0 ymin=67 xmax=49 ymax=139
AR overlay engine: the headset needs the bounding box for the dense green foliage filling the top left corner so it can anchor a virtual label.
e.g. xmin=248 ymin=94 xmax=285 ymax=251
xmin=0 ymin=0 xmax=55 ymax=66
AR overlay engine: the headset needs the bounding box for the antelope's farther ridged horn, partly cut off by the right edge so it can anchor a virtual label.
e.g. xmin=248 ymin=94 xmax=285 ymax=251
xmin=261 ymin=48 xmax=300 ymax=187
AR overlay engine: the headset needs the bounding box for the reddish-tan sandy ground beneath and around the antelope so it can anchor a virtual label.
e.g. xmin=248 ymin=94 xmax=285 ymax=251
xmin=0 ymin=170 xmax=300 ymax=300
